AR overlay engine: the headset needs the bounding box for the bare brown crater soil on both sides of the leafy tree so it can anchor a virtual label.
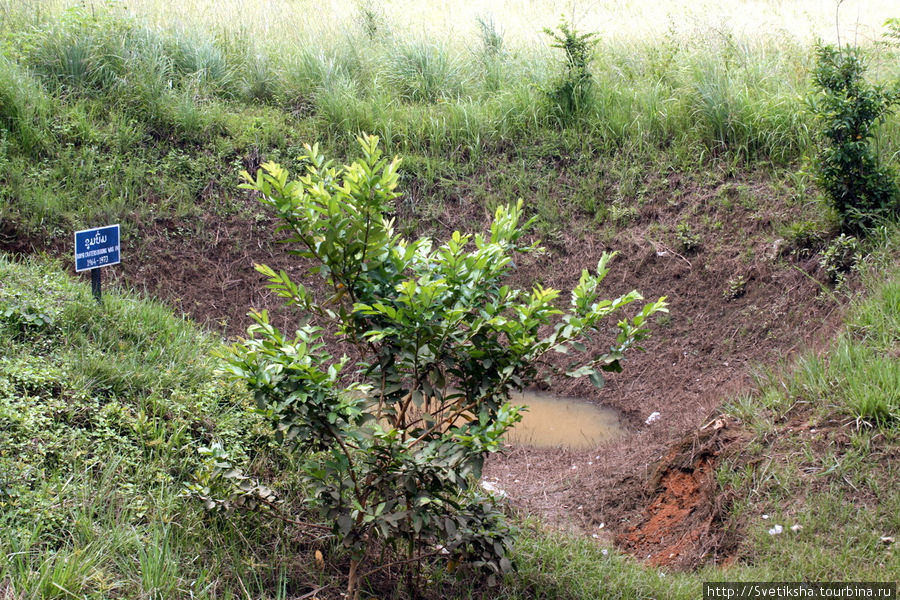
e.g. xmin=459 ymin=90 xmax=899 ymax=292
xmin=0 ymin=166 xmax=840 ymax=567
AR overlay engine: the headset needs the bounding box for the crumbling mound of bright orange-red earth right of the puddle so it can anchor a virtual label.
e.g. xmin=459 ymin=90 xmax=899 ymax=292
xmin=616 ymin=418 xmax=747 ymax=569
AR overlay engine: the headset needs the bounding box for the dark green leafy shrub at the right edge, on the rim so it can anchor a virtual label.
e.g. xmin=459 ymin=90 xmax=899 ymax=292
xmin=811 ymin=45 xmax=900 ymax=232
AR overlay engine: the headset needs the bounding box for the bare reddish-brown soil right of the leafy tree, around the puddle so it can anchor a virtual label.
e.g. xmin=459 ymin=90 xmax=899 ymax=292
xmin=485 ymin=170 xmax=841 ymax=567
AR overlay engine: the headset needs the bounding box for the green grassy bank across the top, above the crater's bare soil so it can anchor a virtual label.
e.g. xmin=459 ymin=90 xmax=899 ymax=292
xmin=0 ymin=0 xmax=900 ymax=236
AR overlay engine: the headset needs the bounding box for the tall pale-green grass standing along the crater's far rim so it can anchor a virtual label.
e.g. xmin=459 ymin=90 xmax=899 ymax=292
xmin=5 ymin=0 xmax=900 ymax=164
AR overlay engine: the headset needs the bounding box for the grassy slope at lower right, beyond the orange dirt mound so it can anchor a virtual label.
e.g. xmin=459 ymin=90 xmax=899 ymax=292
xmin=719 ymin=231 xmax=900 ymax=581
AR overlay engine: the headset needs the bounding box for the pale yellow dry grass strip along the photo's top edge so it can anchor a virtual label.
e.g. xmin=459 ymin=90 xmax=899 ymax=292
xmin=15 ymin=0 xmax=898 ymax=46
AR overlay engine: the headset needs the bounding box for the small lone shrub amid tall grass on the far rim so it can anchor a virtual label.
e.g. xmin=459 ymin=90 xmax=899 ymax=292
xmin=544 ymin=19 xmax=597 ymax=120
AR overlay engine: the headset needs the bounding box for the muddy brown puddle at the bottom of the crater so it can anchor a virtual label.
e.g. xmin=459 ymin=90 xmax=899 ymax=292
xmin=506 ymin=392 xmax=625 ymax=449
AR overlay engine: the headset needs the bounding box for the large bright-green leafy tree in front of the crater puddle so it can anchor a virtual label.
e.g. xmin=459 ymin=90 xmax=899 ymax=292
xmin=219 ymin=137 xmax=666 ymax=598
